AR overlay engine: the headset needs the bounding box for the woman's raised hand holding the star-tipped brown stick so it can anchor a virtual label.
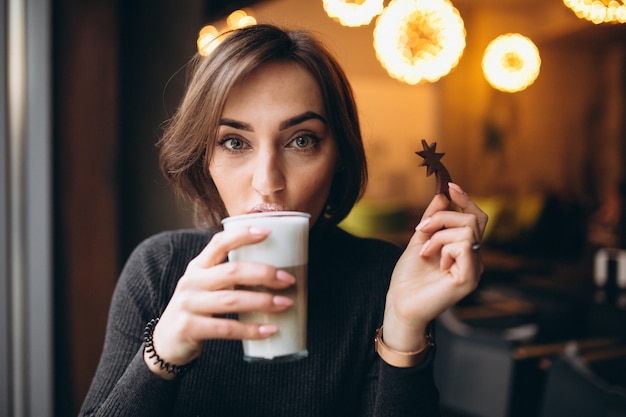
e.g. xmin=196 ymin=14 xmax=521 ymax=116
xmin=383 ymin=183 xmax=487 ymax=352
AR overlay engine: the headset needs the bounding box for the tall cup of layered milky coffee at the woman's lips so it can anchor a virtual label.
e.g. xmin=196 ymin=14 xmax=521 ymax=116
xmin=222 ymin=211 xmax=311 ymax=362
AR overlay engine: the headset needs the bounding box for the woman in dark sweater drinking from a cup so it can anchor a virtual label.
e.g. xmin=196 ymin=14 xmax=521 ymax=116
xmin=81 ymin=25 xmax=487 ymax=416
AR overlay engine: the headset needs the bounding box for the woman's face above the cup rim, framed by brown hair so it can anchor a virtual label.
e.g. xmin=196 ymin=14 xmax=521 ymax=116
xmin=209 ymin=62 xmax=338 ymax=224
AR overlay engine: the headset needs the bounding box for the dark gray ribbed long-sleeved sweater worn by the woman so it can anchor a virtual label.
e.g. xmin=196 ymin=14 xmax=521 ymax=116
xmin=80 ymin=227 xmax=439 ymax=417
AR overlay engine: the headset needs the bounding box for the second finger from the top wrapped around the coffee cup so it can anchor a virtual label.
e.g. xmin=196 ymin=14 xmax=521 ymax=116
xmin=178 ymin=261 xmax=296 ymax=291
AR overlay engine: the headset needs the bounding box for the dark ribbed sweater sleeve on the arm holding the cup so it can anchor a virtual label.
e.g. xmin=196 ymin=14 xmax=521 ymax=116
xmin=79 ymin=231 xmax=207 ymax=417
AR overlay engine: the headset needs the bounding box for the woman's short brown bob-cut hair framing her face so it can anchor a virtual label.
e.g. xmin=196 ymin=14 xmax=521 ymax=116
xmin=158 ymin=25 xmax=367 ymax=226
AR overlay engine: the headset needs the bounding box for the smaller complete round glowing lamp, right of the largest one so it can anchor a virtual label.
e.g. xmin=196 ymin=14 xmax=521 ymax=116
xmin=482 ymin=33 xmax=541 ymax=93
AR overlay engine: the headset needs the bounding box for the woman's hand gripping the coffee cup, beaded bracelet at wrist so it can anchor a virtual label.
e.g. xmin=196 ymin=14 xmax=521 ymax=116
xmin=144 ymin=227 xmax=296 ymax=379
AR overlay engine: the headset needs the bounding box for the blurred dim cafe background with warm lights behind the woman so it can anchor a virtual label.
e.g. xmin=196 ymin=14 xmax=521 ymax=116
xmin=0 ymin=0 xmax=626 ymax=417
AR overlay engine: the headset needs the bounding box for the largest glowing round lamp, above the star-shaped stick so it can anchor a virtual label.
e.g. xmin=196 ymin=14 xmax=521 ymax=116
xmin=374 ymin=0 xmax=465 ymax=85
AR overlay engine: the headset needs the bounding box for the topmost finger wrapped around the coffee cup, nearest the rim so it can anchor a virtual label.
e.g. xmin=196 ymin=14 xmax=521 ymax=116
xmin=191 ymin=227 xmax=271 ymax=268
